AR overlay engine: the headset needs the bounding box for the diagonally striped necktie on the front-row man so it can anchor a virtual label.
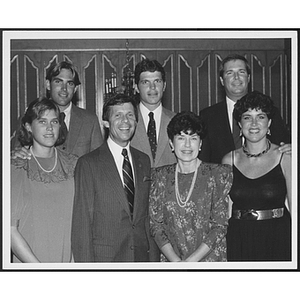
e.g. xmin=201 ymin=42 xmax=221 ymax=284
xmin=122 ymin=148 xmax=134 ymax=215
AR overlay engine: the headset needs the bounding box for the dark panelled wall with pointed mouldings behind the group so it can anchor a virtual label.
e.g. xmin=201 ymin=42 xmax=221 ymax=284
xmin=11 ymin=39 xmax=291 ymax=139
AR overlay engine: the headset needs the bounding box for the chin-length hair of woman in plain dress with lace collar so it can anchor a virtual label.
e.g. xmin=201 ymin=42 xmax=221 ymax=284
xmin=17 ymin=97 xmax=66 ymax=146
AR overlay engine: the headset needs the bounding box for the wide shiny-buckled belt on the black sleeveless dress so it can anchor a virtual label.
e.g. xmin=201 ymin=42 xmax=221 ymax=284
xmin=232 ymin=207 xmax=284 ymax=221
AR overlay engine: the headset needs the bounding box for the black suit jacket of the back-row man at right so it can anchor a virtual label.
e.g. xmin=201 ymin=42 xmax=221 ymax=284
xmin=199 ymin=101 xmax=290 ymax=163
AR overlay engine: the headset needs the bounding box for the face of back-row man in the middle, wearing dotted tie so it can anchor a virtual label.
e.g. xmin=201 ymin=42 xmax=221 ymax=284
xmin=135 ymin=71 xmax=166 ymax=110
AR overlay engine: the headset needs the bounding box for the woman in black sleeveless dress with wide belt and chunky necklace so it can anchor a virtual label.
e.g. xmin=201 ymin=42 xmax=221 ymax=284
xmin=222 ymin=91 xmax=291 ymax=261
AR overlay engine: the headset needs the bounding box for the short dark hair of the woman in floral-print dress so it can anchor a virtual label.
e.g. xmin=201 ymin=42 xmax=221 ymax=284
xmin=167 ymin=111 xmax=206 ymax=141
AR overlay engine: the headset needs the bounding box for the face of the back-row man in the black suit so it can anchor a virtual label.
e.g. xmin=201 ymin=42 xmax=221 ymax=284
xmin=220 ymin=59 xmax=250 ymax=101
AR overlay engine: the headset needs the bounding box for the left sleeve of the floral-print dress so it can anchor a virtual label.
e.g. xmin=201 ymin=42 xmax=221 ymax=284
xmin=149 ymin=169 xmax=169 ymax=249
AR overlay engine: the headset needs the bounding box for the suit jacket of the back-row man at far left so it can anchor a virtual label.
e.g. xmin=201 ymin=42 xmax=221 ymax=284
xmin=58 ymin=105 xmax=103 ymax=157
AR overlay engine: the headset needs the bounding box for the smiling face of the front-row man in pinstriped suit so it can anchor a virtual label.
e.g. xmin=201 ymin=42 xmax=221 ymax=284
xmin=103 ymin=103 xmax=136 ymax=147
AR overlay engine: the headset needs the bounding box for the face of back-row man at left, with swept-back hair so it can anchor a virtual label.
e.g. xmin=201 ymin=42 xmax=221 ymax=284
xmin=46 ymin=69 xmax=77 ymax=111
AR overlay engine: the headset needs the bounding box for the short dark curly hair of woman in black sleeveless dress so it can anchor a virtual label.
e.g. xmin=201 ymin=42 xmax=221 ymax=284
xmin=233 ymin=91 xmax=274 ymax=122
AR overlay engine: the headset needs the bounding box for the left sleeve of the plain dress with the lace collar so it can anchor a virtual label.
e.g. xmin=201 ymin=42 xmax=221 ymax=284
xmin=10 ymin=165 xmax=26 ymax=226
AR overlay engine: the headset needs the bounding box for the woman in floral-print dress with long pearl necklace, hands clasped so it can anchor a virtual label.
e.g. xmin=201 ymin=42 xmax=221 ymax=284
xmin=150 ymin=112 xmax=232 ymax=262
